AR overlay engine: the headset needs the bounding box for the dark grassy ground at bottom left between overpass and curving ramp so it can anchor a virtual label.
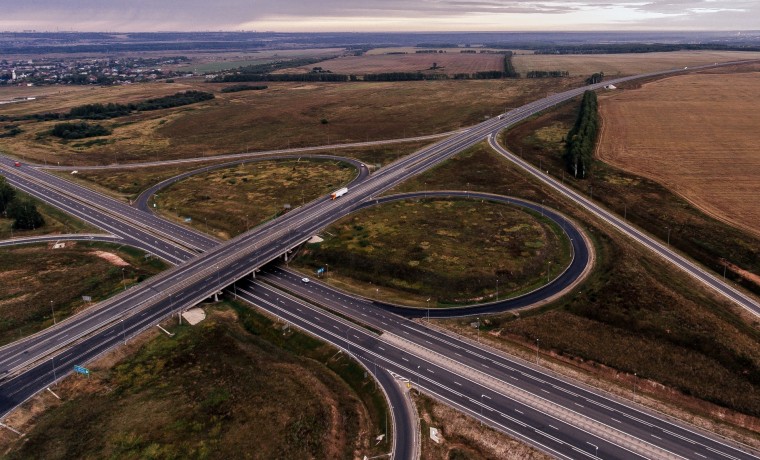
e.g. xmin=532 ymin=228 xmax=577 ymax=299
xmin=3 ymin=304 xmax=391 ymax=459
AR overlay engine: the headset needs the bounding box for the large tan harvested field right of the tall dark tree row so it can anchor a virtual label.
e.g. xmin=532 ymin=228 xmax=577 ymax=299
xmin=598 ymin=73 xmax=760 ymax=235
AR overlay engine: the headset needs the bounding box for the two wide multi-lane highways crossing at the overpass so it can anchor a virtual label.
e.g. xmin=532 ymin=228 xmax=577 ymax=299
xmin=0 ymin=62 xmax=756 ymax=458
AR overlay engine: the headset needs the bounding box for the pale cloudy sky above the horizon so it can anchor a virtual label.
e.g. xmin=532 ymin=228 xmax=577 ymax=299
xmin=0 ymin=0 xmax=760 ymax=32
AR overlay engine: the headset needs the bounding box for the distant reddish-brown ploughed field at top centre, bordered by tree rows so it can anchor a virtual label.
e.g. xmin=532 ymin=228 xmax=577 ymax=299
xmin=288 ymin=54 xmax=504 ymax=75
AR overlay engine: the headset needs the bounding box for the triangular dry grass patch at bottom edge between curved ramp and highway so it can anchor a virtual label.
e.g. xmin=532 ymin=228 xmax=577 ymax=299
xmin=412 ymin=391 xmax=552 ymax=460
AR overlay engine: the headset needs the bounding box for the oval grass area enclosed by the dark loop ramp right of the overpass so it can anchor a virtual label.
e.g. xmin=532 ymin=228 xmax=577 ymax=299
xmin=290 ymin=200 xmax=570 ymax=307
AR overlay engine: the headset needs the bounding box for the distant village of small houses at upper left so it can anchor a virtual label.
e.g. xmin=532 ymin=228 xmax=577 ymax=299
xmin=0 ymin=56 xmax=192 ymax=86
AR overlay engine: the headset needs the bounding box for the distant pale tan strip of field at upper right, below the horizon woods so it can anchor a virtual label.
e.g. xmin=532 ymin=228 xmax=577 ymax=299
xmin=512 ymin=51 xmax=760 ymax=77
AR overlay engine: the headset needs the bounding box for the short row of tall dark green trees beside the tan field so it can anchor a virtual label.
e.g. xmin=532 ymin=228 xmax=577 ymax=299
xmin=564 ymin=91 xmax=599 ymax=178
